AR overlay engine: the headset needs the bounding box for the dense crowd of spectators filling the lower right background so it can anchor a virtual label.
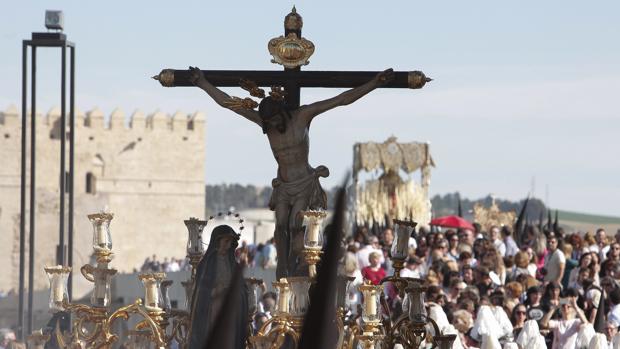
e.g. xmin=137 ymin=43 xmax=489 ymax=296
xmin=237 ymin=224 xmax=620 ymax=349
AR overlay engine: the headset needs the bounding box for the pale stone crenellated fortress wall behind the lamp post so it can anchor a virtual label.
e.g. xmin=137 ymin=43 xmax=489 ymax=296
xmin=0 ymin=106 xmax=205 ymax=294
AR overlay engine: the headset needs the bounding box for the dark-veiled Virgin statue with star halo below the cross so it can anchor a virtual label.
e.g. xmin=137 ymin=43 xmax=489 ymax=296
xmin=189 ymin=225 xmax=248 ymax=349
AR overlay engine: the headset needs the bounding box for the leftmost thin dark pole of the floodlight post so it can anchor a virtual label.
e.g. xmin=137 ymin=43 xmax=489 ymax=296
xmin=17 ymin=41 xmax=28 ymax=341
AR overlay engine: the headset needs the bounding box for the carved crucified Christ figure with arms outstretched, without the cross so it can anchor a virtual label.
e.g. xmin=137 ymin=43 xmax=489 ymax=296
xmin=189 ymin=67 xmax=394 ymax=279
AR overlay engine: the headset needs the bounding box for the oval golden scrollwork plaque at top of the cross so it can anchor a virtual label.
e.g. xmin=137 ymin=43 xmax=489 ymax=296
xmin=267 ymin=33 xmax=314 ymax=69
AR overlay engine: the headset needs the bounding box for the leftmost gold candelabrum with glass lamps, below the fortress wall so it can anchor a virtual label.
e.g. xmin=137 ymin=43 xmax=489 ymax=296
xmin=45 ymin=213 xmax=189 ymax=349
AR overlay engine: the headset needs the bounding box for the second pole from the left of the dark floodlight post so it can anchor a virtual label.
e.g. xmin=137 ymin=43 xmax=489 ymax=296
xmin=26 ymin=46 xmax=37 ymax=333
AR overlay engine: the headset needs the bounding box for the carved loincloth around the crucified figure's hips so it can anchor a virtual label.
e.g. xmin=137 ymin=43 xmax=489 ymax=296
xmin=269 ymin=166 xmax=329 ymax=211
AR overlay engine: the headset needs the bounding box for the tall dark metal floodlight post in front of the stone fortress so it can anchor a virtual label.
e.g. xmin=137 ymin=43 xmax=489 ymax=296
xmin=18 ymin=11 xmax=75 ymax=340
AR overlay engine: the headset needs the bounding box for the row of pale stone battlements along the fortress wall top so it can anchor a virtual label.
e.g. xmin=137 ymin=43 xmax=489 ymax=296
xmin=0 ymin=105 xmax=205 ymax=132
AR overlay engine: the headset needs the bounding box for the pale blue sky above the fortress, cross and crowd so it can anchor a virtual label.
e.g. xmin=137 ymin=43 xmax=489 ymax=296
xmin=0 ymin=1 xmax=620 ymax=215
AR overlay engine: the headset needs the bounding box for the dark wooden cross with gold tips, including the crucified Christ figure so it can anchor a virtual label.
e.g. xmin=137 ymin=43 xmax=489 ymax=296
xmin=153 ymin=7 xmax=431 ymax=279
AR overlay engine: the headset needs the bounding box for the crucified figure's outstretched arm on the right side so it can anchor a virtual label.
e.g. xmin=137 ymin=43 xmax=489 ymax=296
xmin=298 ymin=68 xmax=394 ymax=123
